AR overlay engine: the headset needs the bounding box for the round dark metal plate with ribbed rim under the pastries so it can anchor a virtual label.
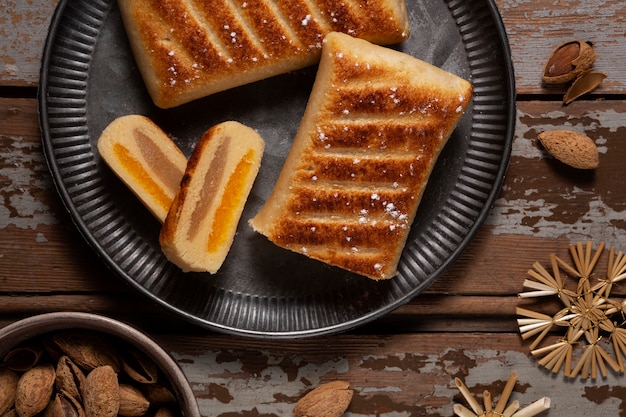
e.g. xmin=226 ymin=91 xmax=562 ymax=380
xmin=39 ymin=0 xmax=515 ymax=338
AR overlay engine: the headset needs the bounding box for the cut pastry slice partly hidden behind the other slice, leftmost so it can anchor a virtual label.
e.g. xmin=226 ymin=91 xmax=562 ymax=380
xmin=98 ymin=115 xmax=187 ymax=222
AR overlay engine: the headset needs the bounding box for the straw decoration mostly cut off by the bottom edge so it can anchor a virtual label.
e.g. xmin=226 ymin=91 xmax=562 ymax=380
xmin=454 ymin=371 xmax=550 ymax=417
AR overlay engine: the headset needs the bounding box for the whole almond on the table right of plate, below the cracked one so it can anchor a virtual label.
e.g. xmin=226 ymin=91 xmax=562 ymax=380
xmin=538 ymin=130 xmax=599 ymax=169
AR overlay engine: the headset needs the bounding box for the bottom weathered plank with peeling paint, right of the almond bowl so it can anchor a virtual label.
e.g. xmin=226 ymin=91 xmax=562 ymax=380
xmin=165 ymin=334 xmax=626 ymax=417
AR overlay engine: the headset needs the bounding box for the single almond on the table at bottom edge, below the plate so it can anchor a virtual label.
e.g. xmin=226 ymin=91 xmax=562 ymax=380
xmin=293 ymin=381 xmax=353 ymax=417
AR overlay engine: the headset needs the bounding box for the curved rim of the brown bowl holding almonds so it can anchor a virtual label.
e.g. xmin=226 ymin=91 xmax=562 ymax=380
xmin=0 ymin=312 xmax=200 ymax=417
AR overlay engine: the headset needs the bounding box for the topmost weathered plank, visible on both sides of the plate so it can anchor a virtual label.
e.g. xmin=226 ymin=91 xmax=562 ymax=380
xmin=0 ymin=0 xmax=626 ymax=94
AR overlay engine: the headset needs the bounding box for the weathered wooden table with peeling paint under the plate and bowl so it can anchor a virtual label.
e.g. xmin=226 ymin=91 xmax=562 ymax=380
xmin=0 ymin=0 xmax=626 ymax=416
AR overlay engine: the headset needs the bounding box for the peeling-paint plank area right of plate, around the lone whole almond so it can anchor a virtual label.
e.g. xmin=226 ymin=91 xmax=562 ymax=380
xmin=486 ymin=101 xmax=626 ymax=249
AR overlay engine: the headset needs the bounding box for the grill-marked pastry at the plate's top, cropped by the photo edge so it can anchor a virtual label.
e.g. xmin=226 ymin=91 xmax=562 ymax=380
xmin=118 ymin=0 xmax=409 ymax=108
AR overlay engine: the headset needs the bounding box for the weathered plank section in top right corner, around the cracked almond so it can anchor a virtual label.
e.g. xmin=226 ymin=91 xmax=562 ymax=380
xmin=496 ymin=0 xmax=626 ymax=94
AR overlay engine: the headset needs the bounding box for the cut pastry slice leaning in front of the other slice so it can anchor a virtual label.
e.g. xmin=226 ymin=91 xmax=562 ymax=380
xmin=159 ymin=122 xmax=264 ymax=273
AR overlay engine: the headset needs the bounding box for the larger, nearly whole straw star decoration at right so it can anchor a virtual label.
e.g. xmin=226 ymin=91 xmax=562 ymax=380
xmin=517 ymin=242 xmax=626 ymax=379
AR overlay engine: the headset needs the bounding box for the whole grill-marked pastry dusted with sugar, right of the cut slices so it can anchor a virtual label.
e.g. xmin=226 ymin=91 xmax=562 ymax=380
xmin=250 ymin=33 xmax=472 ymax=280
